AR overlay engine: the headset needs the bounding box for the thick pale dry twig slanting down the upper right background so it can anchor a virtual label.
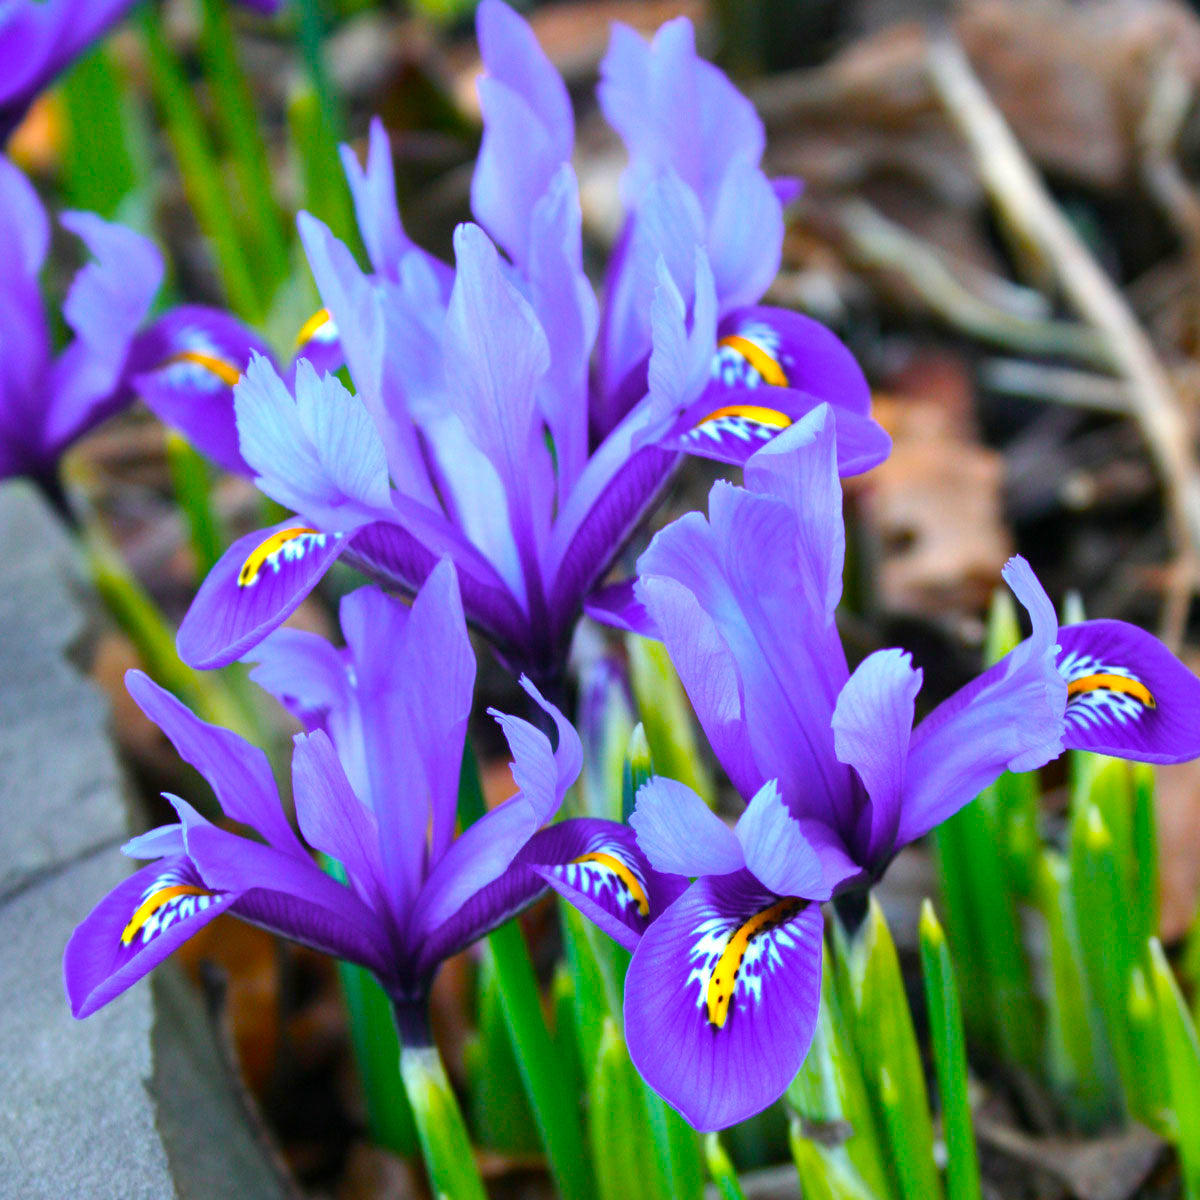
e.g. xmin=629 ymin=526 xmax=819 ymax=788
xmin=929 ymin=37 xmax=1200 ymax=642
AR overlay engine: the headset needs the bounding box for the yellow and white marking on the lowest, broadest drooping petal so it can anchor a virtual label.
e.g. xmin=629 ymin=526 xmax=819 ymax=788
xmin=688 ymin=896 xmax=809 ymax=1030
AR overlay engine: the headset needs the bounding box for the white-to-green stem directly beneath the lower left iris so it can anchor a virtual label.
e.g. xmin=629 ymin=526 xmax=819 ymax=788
xmin=400 ymin=1045 xmax=487 ymax=1200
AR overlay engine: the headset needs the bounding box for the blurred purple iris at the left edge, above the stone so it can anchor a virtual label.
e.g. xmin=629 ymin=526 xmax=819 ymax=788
xmin=0 ymin=157 xmax=271 ymax=490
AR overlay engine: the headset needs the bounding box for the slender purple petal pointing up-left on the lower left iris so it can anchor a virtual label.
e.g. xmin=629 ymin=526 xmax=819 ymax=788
xmin=125 ymin=671 xmax=304 ymax=854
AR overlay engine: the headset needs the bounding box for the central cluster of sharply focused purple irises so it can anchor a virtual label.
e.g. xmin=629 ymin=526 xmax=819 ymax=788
xmin=60 ymin=0 xmax=1200 ymax=1129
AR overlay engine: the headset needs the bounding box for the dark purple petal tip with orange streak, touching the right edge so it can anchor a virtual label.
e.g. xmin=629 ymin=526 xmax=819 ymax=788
xmin=1058 ymin=620 xmax=1200 ymax=762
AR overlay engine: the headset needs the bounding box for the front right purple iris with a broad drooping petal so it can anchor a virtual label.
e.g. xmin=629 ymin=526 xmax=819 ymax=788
xmin=625 ymin=409 xmax=1200 ymax=1129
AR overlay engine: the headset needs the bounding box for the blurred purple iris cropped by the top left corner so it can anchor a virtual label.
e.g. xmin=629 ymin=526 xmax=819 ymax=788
xmin=0 ymin=0 xmax=282 ymax=145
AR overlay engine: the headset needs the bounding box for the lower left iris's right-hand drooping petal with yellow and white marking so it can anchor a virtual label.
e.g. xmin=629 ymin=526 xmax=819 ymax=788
xmin=516 ymin=817 xmax=688 ymax=950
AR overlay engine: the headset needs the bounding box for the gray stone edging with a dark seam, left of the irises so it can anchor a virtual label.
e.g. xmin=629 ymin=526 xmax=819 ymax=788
xmin=0 ymin=484 xmax=289 ymax=1200
